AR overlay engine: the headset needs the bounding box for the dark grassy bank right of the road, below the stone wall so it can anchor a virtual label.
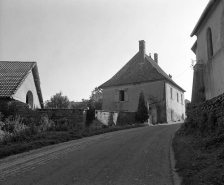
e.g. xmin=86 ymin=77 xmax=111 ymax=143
xmin=172 ymin=123 xmax=224 ymax=185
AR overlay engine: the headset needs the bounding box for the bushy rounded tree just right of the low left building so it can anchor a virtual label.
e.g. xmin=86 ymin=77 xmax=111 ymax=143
xmin=45 ymin=91 xmax=70 ymax=109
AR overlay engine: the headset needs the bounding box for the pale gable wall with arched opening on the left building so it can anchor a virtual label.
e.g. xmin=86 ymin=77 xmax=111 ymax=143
xmin=12 ymin=71 xmax=40 ymax=108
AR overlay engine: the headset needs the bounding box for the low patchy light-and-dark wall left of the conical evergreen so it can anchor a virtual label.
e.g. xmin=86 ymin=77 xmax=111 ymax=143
xmin=95 ymin=110 xmax=136 ymax=125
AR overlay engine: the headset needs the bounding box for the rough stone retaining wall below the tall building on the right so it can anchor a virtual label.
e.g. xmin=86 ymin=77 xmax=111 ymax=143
xmin=186 ymin=94 xmax=224 ymax=124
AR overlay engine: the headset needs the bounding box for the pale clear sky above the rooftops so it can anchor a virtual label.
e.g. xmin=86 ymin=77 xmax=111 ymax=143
xmin=0 ymin=0 xmax=209 ymax=101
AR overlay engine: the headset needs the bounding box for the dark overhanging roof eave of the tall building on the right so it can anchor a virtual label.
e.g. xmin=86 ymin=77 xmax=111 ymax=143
xmin=191 ymin=0 xmax=220 ymax=37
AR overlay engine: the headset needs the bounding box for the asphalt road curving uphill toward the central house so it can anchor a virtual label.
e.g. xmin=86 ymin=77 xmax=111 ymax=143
xmin=0 ymin=124 xmax=180 ymax=185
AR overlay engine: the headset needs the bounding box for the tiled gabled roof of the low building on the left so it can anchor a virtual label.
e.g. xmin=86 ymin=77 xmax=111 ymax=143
xmin=0 ymin=61 xmax=43 ymax=108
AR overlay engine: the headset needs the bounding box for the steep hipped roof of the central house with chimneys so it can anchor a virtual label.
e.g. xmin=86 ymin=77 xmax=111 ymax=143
xmin=99 ymin=52 xmax=185 ymax=92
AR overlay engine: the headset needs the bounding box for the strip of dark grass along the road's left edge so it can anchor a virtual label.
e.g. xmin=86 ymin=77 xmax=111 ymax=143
xmin=0 ymin=124 xmax=145 ymax=159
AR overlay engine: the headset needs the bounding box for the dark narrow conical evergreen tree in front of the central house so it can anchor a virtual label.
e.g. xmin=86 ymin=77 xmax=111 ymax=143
xmin=136 ymin=91 xmax=149 ymax=123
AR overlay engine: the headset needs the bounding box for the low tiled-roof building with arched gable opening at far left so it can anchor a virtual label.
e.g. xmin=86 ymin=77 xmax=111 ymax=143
xmin=0 ymin=61 xmax=44 ymax=109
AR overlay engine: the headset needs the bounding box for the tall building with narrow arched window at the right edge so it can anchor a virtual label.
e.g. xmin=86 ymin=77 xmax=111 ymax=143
xmin=191 ymin=0 xmax=224 ymax=103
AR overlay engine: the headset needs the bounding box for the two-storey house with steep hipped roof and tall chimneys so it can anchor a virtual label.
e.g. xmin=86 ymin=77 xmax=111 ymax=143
xmin=99 ymin=40 xmax=185 ymax=124
